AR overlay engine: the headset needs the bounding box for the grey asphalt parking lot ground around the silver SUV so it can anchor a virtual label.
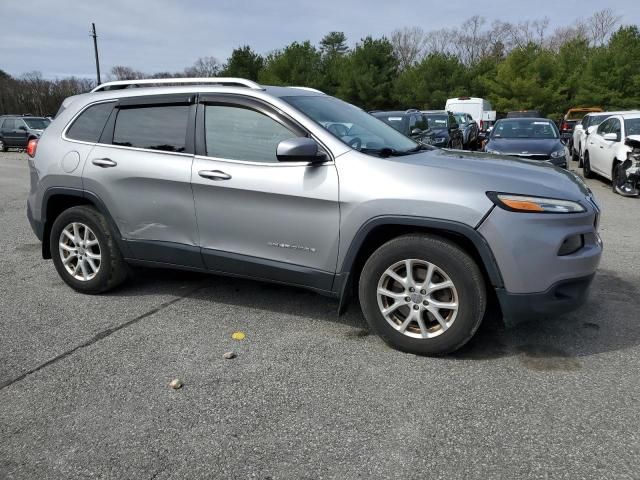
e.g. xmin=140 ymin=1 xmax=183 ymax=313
xmin=0 ymin=153 xmax=640 ymax=479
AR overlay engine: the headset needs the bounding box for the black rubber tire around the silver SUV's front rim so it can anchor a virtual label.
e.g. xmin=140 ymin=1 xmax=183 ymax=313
xmin=359 ymin=234 xmax=487 ymax=355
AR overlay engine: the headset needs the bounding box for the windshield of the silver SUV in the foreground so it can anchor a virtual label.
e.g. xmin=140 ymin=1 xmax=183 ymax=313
xmin=282 ymin=95 xmax=419 ymax=154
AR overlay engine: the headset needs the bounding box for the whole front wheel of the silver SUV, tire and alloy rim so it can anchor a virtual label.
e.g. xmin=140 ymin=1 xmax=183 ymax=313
xmin=359 ymin=235 xmax=486 ymax=355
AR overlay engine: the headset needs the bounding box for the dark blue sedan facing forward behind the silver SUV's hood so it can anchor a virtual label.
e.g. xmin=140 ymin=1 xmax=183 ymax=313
xmin=484 ymin=118 xmax=568 ymax=168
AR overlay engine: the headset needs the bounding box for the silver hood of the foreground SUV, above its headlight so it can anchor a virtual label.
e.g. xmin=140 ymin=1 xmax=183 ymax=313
xmin=393 ymin=150 xmax=590 ymax=201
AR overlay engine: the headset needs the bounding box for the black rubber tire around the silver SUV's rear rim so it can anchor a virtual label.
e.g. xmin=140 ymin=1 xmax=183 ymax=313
xmin=49 ymin=206 xmax=128 ymax=294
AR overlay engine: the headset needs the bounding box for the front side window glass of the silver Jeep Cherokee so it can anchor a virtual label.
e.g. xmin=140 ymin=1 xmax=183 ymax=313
xmin=204 ymin=105 xmax=297 ymax=163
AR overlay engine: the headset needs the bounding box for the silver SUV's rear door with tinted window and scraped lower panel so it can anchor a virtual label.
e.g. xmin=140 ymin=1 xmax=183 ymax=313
xmin=83 ymin=94 xmax=202 ymax=267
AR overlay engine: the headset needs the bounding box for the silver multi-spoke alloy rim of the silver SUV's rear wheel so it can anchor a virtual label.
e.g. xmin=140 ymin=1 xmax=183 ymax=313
xmin=58 ymin=222 xmax=102 ymax=282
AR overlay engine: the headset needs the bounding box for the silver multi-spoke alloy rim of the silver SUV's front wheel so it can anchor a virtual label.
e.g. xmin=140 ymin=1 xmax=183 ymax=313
xmin=377 ymin=259 xmax=458 ymax=338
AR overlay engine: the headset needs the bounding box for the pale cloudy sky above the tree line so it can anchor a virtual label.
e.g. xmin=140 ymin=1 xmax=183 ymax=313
xmin=0 ymin=0 xmax=640 ymax=78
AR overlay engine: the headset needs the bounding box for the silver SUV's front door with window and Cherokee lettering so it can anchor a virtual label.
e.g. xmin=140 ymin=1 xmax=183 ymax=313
xmin=192 ymin=95 xmax=340 ymax=290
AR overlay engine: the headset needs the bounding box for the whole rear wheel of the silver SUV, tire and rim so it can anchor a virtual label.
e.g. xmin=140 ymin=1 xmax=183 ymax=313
xmin=49 ymin=206 xmax=127 ymax=294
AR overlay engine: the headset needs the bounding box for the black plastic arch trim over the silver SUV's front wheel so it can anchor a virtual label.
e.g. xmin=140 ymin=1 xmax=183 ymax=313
xmin=333 ymin=215 xmax=504 ymax=291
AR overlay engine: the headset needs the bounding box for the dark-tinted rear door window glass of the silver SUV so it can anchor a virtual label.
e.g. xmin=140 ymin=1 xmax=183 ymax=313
xmin=113 ymin=105 xmax=189 ymax=152
